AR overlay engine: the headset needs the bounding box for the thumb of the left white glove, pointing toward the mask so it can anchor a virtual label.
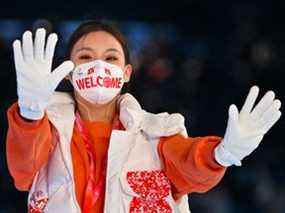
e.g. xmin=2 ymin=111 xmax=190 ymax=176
xmin=49 ymin=61 xmax=74 ymax=89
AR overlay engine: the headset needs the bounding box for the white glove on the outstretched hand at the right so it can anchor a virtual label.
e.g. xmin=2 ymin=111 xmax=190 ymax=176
xmin=215 ymin=86 xmax=281 ymax=167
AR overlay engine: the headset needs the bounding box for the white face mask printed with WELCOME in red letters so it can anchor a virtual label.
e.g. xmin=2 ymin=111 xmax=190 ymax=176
xmin=72 ymin=60 xmax=124 ymax=104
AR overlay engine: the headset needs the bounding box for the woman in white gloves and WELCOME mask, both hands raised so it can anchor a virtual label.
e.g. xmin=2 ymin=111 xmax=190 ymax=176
xmin=7 ymin=21 xmax=281 ymax=213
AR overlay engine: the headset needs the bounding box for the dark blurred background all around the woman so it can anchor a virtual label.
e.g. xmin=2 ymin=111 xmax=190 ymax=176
xmin=0 ymin=0 xmax=285 ymax=213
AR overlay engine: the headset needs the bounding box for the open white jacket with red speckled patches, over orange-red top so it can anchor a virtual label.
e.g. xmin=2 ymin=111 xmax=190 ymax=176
xmin=28 ymin=92 xmax=190 ymax=213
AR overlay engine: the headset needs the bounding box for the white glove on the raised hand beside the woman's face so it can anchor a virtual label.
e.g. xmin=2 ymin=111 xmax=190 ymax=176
xmin=13 ymin=28 xmax=74 ymax=120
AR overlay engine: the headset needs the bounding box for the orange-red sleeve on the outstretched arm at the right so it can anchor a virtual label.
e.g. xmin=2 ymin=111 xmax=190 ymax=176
xmin=158 ymin=135 xmax=226 ymax=199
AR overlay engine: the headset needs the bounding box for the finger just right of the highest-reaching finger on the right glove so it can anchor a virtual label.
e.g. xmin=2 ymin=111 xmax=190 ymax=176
xmin=251 ymin=91 xmax=275 ymax=120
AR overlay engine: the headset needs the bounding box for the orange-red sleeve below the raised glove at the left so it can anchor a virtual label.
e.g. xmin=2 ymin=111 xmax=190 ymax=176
xmin=6 ymin=103 xmax=52 ymax=191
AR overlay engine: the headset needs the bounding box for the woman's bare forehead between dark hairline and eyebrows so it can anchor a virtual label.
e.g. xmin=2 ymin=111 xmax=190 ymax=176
xmin=72 ymin=31 xmax=123 ymax=53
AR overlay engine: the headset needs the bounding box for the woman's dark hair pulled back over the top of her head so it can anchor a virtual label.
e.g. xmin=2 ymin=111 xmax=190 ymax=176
xmin=67 ymin=20 xmax=131 ymax=64
